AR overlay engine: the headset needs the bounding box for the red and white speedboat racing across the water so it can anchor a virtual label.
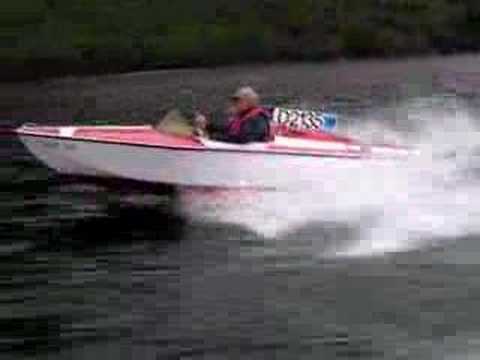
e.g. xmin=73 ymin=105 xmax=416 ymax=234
xmin=7 ymin=109 xmax=412 ymax=188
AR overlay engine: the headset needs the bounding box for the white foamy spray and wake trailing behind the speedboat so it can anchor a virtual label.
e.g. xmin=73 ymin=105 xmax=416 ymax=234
xmin=179 ymin=99 xmax=480 ymax=257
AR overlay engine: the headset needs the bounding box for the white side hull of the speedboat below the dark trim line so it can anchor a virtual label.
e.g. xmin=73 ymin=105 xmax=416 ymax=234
xmin=20 ymin=136 xmax=382 ymax=188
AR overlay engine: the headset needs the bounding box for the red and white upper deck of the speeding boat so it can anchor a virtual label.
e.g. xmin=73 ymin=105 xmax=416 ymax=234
xmin=17 ymin=125 xmax=412 ymax=157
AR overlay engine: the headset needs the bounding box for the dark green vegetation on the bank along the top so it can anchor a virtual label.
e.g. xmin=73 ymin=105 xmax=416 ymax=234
xmin=0 ymin=0 xmax=480 ymax=77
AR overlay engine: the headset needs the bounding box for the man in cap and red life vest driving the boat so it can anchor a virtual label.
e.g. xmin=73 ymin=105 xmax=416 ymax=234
xmin=195 ymin=87 xmax=271 ymax=144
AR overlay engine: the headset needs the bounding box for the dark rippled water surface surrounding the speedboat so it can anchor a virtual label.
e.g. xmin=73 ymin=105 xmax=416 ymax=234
xmin=0 ymin=56 xmax=480 ymax=359
